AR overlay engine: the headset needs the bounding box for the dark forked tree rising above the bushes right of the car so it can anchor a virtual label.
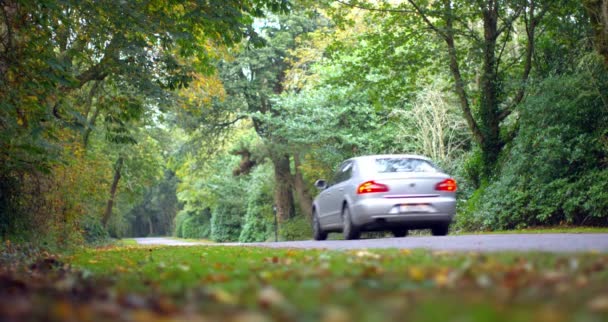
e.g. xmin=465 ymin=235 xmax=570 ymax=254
xmin=328 ymin=0 xmax=550 ymax=178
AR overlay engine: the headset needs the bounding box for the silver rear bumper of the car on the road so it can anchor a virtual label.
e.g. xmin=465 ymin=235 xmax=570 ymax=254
xmin=351 ymin=197 xmax=456 ymax=228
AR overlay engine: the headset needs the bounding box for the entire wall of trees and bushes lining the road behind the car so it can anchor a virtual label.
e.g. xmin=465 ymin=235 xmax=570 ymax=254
xmin=0 ymin=0 xmax=608 ymax=249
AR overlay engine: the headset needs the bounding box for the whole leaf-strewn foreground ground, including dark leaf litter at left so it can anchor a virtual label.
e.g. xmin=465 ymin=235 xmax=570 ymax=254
xmin=0 ymin=246 xmax=608 ymax=321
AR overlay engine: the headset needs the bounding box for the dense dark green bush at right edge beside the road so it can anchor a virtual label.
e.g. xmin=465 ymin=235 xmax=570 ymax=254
xmin=463 ymin=55 xmax=608 ymax=229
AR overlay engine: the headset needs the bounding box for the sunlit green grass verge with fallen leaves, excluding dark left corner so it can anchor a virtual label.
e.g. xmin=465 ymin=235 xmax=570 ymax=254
xmin=68 ymin=246 xmax=608 ymax=321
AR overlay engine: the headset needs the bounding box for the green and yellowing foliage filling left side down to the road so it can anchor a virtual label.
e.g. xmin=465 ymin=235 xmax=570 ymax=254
xmin=0 ymin=0 xmax=289 ymax=244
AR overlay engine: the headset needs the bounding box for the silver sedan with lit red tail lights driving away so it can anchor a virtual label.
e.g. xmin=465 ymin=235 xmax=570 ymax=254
xmin=312 ymin=154 xmax=457 ymax=240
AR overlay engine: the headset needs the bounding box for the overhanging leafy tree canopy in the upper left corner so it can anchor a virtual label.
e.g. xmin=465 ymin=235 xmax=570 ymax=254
xmin=0 ymin=0 xmax=290 ymax=243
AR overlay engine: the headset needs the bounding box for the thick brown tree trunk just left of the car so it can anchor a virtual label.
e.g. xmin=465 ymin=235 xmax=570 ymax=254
xmin=272 ymin=155 xmax=295 ymax=222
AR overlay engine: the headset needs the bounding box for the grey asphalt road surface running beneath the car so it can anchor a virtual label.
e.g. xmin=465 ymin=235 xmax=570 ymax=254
xmin=136 ymin=234 xmax=608 ymax=253
